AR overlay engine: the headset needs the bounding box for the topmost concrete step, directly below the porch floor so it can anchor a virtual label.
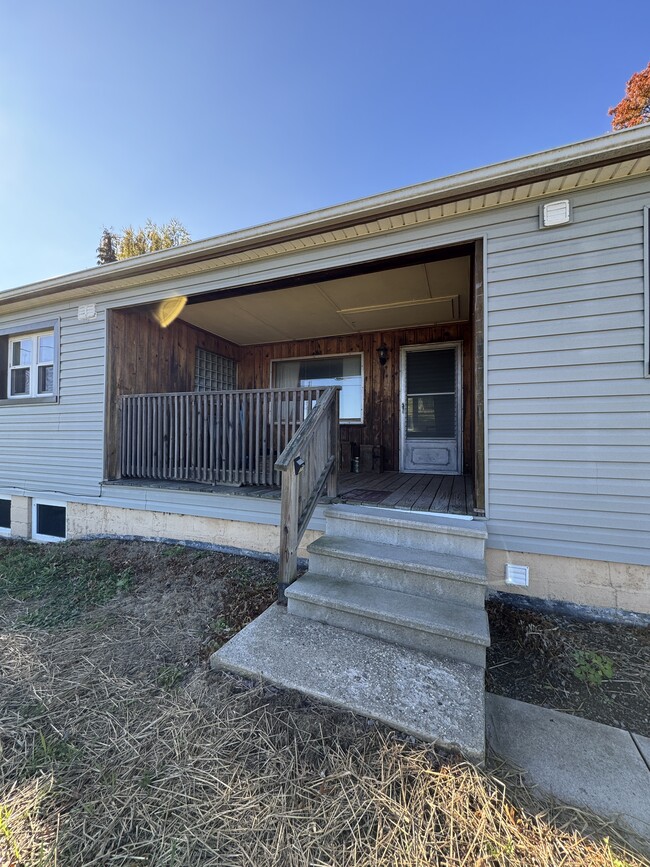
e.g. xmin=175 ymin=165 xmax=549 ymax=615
xmin=325 ymin=504 xmax=487 ymax=559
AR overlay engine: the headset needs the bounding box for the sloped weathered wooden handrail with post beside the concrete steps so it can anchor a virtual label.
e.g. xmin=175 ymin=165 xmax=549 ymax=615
xmin=275 ymin=387 xmax=340 ymax=603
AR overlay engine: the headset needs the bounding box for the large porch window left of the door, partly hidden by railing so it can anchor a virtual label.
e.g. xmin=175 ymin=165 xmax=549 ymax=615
xmin=272 ymin=353 xmax=363 ymax=424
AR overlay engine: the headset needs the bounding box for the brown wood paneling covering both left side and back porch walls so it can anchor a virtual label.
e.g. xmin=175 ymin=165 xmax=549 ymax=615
xmin=105 ymin=309 xmax=475 ymax=478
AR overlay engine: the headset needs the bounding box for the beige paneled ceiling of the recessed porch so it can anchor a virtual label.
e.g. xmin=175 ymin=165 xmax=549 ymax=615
xmin=181 ymin=256 xmax=470 ymax=345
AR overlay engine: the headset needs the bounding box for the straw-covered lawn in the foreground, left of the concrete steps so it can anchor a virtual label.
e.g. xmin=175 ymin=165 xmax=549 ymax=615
xmin=0 ymin=542 xmax=649 ymax=867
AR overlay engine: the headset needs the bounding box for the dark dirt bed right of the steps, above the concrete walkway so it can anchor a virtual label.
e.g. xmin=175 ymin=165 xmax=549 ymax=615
xmin=486 ymin=601 xmax=650 ymax=737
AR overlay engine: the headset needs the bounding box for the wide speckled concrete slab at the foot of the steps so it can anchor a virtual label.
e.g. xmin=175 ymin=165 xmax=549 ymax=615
xmin=210 ymin=605 xmax=485 ymax=762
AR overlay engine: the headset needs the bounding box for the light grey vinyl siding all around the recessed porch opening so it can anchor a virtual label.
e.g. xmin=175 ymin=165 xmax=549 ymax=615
xmin=0 ymin=177 xmax=650 ymax=564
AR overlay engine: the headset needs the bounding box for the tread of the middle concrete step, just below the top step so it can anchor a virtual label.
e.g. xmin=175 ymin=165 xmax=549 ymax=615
xmin=307 ymin=535 xmax=487 ymax=584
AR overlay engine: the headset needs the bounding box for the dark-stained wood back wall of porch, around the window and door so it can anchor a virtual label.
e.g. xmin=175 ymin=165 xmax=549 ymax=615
xmin=239 ymin=323 xmax=474 ymax=473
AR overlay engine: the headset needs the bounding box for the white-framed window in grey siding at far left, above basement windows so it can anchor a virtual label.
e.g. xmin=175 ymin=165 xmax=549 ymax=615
xmin=7 ymin=330 xmax=55 ymax=398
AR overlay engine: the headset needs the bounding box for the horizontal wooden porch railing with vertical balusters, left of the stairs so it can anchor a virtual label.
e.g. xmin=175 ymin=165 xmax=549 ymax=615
xmin=120 ymin=388 xmax=331 ymax=486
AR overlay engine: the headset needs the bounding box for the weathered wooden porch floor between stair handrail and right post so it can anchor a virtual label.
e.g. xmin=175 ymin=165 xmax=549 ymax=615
xmin=338 ymin=472 xmax=474 ymax=515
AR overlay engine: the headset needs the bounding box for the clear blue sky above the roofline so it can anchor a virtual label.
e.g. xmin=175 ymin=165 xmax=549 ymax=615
xmin=0 ymin=0 xmax=650 ymax=289
